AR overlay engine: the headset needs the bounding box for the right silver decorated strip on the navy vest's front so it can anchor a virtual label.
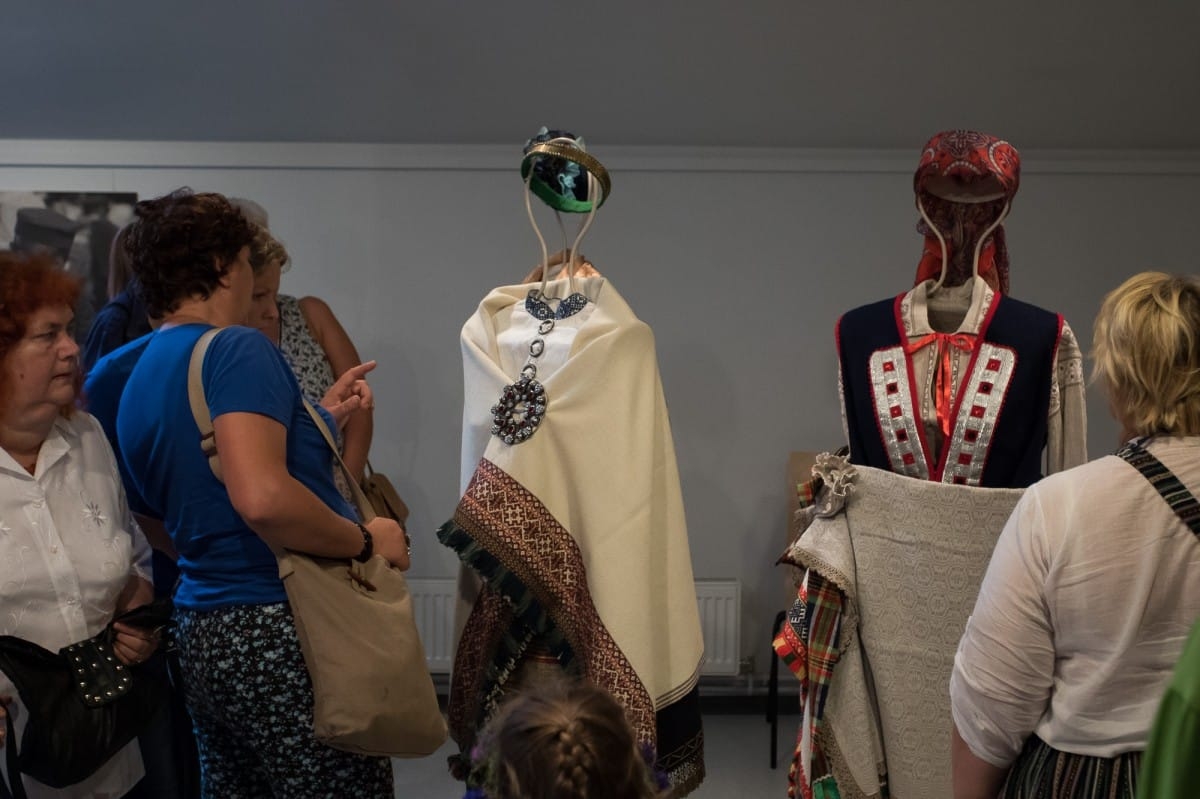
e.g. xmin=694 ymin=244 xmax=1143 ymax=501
xmin=942 ymin=342 xmax=1016 ymax=486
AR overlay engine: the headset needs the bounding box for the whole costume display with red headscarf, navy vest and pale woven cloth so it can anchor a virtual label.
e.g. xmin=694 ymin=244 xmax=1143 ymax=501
xmin=775 ymin=131 xmax=1087 ymax=799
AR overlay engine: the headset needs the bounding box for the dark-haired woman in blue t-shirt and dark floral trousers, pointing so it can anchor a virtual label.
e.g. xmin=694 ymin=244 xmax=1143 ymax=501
xmin=116 ymin=190 xmax=408 ymax=799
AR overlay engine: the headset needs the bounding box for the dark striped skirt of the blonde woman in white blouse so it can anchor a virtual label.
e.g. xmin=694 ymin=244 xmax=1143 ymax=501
xmin=1000 ymin=735 xmax=1141 ymax=799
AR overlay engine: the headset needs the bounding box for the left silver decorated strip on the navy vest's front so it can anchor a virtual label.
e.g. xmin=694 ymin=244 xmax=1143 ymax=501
xmin=870 ymin=347 xmax=929 ymax=480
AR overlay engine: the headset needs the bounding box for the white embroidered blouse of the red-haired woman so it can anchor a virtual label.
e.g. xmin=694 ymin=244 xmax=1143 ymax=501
xmin=0 ymin=411 xmax=150 ymax=799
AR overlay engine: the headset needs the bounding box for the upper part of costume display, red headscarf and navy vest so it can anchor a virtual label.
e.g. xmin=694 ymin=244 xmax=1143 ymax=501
xmin=836 ymin=131 xmax=1087 ymax=488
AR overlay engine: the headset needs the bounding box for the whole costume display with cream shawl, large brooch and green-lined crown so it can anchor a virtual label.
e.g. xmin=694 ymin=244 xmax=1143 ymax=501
xmin=438 ymin=132 xmax=704 ymax=795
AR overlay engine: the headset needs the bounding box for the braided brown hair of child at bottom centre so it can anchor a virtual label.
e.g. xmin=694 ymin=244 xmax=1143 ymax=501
xmin=467 ymin=683 xmax=667 ymax=799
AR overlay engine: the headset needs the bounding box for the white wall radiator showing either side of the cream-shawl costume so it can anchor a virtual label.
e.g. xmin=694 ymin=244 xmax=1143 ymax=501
xmin=408 ymin=578 xmax=742 ymax=677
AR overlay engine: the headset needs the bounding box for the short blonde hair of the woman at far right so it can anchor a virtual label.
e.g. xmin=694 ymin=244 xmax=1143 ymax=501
xmin=1092 ymin=272 xmax=1200 ymax=435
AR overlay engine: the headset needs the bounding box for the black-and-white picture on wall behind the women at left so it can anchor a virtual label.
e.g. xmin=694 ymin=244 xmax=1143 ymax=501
xmin=0 ymin=191 xmax=138 ymax=341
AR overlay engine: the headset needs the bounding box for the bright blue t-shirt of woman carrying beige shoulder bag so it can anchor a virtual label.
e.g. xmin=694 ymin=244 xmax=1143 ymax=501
xmin=116 ymin=324 xmax=355 ymax=611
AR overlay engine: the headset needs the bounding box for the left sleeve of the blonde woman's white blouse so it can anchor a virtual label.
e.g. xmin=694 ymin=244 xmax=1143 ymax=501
xmin=950 ymin=487 xmax=1055 ymax=768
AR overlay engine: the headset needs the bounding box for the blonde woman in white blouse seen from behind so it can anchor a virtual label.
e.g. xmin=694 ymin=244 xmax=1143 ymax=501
xmin=950 ymin=272 xmax=1200 ymax=799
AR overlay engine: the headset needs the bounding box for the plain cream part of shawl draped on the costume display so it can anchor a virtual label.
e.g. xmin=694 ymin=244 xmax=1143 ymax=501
xmin=460 ymin=276 xmax=703 ymax=719
